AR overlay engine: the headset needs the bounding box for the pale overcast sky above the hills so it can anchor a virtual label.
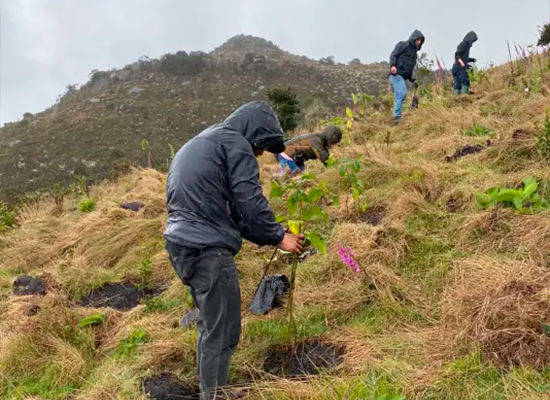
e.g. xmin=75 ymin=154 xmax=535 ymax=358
xmin=0 ymin=0 xmax=550 ymax=126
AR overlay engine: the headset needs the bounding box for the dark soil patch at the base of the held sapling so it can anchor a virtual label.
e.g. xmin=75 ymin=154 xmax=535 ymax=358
xmin=263 ymin=341 xmax=344 ymax=377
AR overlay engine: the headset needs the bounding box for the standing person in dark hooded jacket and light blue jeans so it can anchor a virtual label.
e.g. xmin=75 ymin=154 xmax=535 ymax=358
xmin=388 ymin=30 xmax=425 ymax=124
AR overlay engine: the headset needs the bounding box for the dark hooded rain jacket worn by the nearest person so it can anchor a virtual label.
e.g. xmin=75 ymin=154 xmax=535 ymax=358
xmin=164 ymin=101 xmax=284 ymax=254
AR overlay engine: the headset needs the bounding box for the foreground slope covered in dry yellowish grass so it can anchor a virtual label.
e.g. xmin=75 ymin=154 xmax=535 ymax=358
xmin=0 ymin=57 xmax=550 ymax=400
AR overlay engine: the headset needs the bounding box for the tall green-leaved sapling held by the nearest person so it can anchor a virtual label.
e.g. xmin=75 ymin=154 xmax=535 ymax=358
xmin=270 ymin=174 xmax=338 ymax=349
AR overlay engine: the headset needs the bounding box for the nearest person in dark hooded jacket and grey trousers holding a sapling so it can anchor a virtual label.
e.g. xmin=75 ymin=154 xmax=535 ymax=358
xmin=164 ymin=101 xmax=303 ymax=399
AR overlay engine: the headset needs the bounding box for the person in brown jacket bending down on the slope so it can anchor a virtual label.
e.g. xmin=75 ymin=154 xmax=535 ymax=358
xmin=277 ymin=125 xmax=342 ymax=175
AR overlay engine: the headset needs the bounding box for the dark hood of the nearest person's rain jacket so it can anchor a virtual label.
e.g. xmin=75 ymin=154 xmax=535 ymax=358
xmin=223 ymin=101 xmax=285 ymax=153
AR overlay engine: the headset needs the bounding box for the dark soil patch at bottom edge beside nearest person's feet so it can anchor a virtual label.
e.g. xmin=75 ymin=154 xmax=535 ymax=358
xmin=143 ymin=372 xmax=199 ymax=400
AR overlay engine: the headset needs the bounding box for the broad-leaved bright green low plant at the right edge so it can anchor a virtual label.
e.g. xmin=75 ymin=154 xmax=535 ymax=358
xmin=476 ymin=177 xmax=548 ymax=212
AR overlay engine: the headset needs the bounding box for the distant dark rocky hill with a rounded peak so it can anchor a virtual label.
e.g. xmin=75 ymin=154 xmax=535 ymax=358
xmin=0 ymin=35 xmax=387 ymax=201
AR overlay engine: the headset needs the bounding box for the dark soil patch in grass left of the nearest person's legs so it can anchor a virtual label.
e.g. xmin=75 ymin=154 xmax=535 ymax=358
xmin=78 ymin=282 xmax=158 ymax=311
